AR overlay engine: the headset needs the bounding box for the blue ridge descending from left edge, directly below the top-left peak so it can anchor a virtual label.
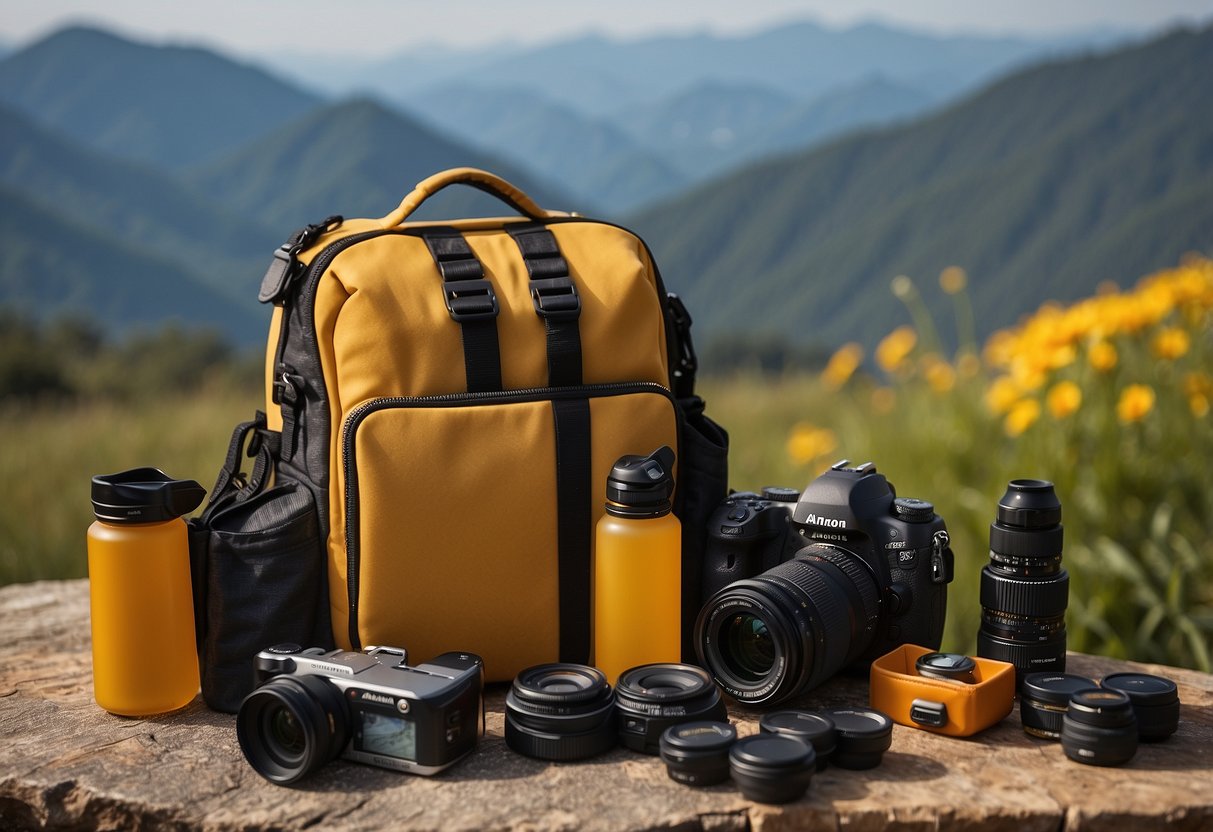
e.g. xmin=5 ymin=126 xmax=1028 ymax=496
xmin=0 ymin=107 xmax=280 ymax=300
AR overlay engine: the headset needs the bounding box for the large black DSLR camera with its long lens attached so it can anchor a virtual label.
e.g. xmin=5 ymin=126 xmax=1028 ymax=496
xmin=695 ymin=460 xmax=953 ymax=705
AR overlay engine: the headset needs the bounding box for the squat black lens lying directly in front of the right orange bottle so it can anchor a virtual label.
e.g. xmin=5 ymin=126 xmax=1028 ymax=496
xmin=615 ymin=663 xmax=728 ymax=754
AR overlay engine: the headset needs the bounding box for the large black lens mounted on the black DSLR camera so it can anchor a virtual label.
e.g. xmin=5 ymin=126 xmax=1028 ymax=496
xmin=695 ymin=543 xmax=879 ymax=705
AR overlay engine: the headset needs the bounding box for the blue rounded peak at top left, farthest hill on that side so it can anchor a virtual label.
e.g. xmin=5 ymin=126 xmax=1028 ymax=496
xmin=0 ymin=27 xmax=319 ymax=169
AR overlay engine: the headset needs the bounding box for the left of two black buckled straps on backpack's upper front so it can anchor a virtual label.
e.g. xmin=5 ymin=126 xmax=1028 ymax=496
xmin=421 ymin=226 xmax=502 ymax=393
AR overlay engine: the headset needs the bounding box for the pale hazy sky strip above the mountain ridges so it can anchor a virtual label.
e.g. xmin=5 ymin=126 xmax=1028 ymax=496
xmin=0 ymin=0 xmax=1213 ymax=55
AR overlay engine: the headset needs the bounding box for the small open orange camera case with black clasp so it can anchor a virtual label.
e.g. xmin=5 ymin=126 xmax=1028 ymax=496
xmin=869 ymin=644 xmax=1015 ymax=736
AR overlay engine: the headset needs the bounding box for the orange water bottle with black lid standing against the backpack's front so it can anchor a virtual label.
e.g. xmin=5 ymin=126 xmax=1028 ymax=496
xmin=594 ymin=445 xmax=682 ymax=684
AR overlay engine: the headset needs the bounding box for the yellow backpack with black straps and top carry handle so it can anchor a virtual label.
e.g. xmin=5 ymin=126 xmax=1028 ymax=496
xmin=186 ymin=169 xmax=728 ymax=708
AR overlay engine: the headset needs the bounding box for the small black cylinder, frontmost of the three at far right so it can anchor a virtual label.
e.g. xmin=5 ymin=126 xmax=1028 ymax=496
xmin=1061 ymin=688 xmax=1138 ymax=765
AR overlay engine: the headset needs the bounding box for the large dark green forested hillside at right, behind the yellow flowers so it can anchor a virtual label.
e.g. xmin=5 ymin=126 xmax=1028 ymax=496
xmin=628 ymin=28 xmax=1213 ymax=344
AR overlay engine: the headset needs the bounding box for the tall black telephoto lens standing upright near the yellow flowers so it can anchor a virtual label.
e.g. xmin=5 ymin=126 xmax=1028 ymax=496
xmin=978 ymin=479 xmax=1070 ymax=683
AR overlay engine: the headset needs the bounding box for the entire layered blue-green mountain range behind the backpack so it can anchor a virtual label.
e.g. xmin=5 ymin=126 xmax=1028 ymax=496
xmin=0 ymin=18 xmax=1213 ymax=344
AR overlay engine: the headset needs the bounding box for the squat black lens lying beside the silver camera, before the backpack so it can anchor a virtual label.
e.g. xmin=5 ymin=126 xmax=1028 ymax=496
xmin=506 ymin=662 xmax=616 ymax=762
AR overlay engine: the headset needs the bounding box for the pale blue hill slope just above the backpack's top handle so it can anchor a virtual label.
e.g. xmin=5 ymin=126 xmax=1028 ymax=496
xmin=402 ymin=86 xmax=687 ymax=213
